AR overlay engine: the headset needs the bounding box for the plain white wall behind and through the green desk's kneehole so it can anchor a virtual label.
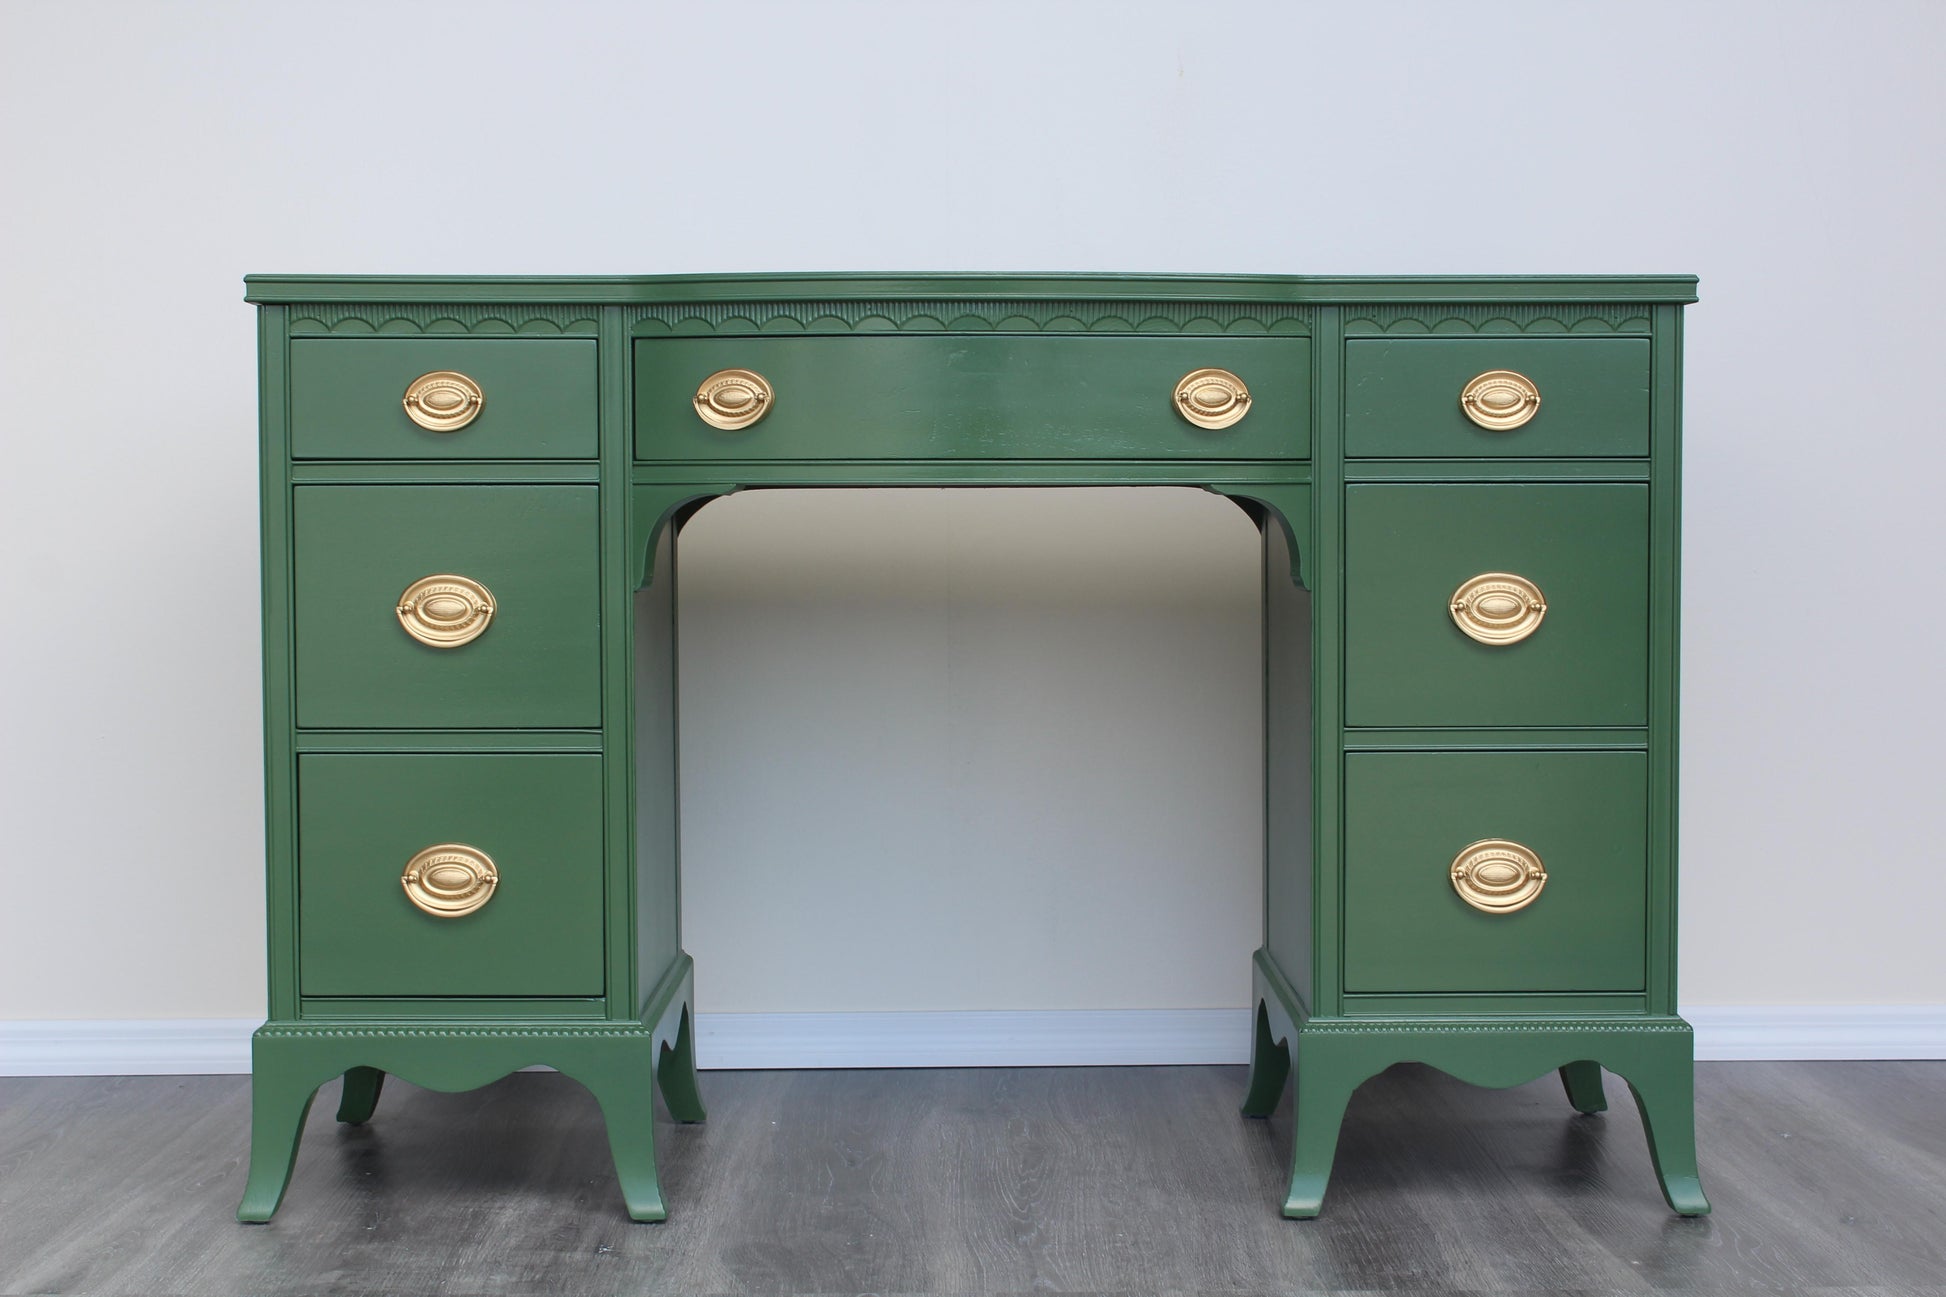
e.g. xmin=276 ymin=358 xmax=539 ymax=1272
xmin=0 ymin=0 xmax=1946 ymax=1019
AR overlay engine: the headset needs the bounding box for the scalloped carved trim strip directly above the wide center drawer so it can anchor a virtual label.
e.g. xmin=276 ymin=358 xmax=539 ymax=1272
xmin=629 ymin=300 xmax=1314 ymax=337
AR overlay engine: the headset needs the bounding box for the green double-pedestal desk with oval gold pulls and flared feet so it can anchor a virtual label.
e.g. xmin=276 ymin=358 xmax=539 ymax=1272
xmin=239 ymin=266 xmax=1709 ymax=1221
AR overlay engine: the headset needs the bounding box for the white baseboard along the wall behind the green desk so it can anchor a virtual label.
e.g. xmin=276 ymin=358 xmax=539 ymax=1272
xmin=0 ymin=1005 xmax=1946 ymax=1077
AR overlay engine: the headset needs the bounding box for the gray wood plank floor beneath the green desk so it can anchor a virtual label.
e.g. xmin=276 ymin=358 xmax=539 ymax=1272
xmin=0 ymin=1063 xmax=1946 ymax=1295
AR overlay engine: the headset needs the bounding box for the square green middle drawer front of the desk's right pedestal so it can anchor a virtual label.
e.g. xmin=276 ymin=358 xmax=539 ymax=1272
xmin=1345 ymin=483 xmax=1648 ymax=726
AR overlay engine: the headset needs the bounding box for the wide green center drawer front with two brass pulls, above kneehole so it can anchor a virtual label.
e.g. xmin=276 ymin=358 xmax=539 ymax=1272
xmin=634 ymin=335 xmax=1312 ymax=460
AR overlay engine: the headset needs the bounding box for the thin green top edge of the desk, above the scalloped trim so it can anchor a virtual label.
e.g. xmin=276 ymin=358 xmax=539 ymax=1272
xmin=243 ymin=273 xmax=1697 ymax=306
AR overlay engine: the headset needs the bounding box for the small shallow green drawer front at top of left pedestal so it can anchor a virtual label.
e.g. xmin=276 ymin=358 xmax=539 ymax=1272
xmin=290 ymin=339 xmax=599 ymax=460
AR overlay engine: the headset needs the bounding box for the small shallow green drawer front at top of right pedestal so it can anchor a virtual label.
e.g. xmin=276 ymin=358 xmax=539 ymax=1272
xmin=1345 ymin=337 xmax=1648 ymax=460
